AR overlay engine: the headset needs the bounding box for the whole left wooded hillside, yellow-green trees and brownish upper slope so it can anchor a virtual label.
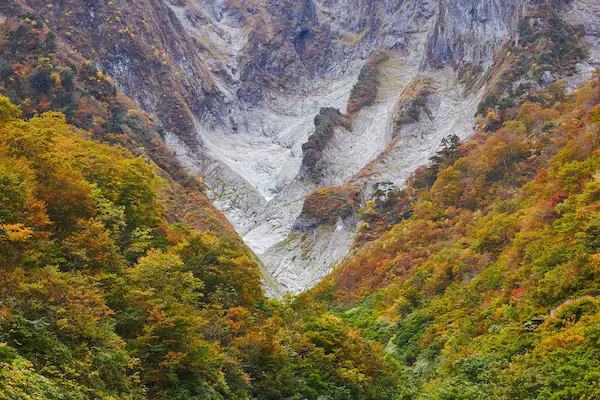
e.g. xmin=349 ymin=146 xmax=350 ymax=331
xmin=0 ymin=10 xmax=398 ymax=400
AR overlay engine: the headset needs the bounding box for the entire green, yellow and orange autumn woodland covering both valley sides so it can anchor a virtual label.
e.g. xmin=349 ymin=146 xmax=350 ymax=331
xmin=0 ymin=5 xmax=600 ymax=400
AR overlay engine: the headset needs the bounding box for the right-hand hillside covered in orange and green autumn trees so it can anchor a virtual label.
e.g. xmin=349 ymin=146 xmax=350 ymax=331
xmin=313 ymin=50 xmax=600 ymax=399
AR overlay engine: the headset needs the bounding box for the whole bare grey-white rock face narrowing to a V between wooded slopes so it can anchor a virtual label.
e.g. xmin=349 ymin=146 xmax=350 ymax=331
xmin=15 ymin=0 xmax=600 ymax=292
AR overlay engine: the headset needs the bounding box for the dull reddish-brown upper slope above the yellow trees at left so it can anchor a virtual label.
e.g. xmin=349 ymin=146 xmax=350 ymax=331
xmin=0 ymin=6 xmax=241 ymax=241
